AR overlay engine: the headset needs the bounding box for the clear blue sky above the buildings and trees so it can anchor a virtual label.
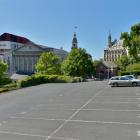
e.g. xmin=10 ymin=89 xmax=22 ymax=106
xmin=0 ymin=0 xmax=140 ymax=59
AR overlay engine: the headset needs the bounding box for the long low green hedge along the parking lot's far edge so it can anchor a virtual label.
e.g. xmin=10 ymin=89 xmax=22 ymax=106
xmin=19 ymin=74 xmax=82 ymax=87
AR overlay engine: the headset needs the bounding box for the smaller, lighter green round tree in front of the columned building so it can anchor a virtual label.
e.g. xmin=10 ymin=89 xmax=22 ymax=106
xmin=36 ymin=52 xmax=61 ymax=74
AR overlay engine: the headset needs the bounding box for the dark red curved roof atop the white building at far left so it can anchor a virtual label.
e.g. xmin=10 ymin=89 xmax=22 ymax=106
xmin=0 ymin=33 xmax=30 ymax=44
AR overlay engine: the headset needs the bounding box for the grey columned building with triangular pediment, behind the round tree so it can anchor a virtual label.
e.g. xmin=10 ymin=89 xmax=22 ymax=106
xmin=12 ymin=42 xmax=68 ymax=75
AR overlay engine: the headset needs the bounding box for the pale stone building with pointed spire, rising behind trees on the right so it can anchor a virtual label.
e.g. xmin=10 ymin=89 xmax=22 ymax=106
xmin=104 ymin=33 xmax=128 ymax=62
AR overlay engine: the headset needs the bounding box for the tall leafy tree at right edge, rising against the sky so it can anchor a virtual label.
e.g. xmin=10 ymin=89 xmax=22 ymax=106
xmin=121 ymin=23 xmax=140 ymax=61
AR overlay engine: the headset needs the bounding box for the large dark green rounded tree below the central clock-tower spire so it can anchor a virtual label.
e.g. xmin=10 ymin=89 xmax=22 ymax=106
xmin=62 ymin=48 xmax=93 ymax=78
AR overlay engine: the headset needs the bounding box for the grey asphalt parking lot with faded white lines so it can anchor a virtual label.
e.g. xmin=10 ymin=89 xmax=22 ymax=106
xmin=0 ymin=81 xmax=140 ymax=140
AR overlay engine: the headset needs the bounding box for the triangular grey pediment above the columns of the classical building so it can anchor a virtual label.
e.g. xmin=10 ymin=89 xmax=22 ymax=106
xmin=15 ymin=44 xmax=43 ymax=52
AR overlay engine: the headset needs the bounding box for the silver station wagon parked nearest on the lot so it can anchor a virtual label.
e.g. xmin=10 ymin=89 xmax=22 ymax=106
xmin=108 ymin=76 xmax=140 ymax=87
